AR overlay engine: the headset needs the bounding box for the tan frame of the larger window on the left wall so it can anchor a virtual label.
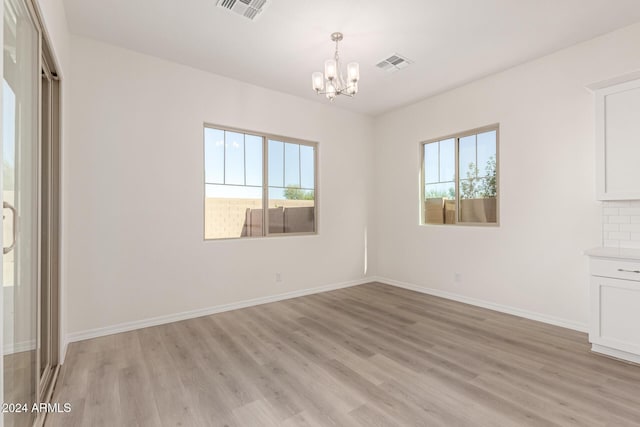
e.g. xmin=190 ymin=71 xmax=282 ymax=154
xmin=201 ymin=122 xmax=320 ymax=242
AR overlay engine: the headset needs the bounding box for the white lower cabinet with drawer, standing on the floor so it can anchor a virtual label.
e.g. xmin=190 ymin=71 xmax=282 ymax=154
xmin=589 ymin=254 xmax=640 ymax=363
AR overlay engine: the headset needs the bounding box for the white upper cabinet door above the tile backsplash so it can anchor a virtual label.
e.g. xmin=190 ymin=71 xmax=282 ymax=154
xmin=595 ymin=79 xmax=640 ymax=200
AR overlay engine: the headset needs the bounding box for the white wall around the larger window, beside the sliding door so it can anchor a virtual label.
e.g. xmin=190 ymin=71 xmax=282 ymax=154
xmin=65 ymin=37 xmax=373 ymax=336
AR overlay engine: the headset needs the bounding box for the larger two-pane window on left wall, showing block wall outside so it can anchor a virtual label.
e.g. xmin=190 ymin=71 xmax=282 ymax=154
xmin=204 ymin=126 xmax=317 ymax=239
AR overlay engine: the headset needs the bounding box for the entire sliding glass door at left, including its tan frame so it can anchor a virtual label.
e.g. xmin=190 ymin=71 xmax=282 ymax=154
xmin=2 ymin=0 xmax=60 ymax=427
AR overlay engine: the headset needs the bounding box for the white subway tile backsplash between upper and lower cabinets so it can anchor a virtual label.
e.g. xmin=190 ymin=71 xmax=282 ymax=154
xmin=602 ymin=200 xmax=640 ymax=249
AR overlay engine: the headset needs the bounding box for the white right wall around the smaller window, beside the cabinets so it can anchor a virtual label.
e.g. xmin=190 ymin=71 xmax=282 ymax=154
xmin=374 ymin=21 xmax=640 ymax=328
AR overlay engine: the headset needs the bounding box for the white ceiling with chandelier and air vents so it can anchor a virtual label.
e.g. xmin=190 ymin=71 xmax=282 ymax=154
xmin=65 ymin=0 xmax=640 ymax=115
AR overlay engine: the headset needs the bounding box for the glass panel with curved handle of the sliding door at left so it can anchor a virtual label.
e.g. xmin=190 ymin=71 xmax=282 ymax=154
xmin=2 ymin=0 xmax=40 ymax=427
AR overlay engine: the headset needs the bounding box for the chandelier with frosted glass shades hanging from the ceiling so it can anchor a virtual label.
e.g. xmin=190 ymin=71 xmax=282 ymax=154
xmin=311 ymin=32 xmax=360 ymax=101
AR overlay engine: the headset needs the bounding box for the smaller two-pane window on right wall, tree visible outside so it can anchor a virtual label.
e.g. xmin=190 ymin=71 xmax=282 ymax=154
xmin=420 ymin=125 xmax=499 ymax=225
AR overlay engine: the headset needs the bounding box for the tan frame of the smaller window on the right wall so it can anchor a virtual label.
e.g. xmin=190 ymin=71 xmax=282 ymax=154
xmin=418 ymin=123 xmax=500 ymax=227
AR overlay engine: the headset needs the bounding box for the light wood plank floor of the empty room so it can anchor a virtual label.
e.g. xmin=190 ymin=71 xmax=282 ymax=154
xmin=46 ymin=283 xmax=640 ymax=427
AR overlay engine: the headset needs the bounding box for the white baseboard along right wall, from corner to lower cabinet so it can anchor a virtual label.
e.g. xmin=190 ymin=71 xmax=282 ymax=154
xmin=370 ymin=277 xmax=589 ymax=332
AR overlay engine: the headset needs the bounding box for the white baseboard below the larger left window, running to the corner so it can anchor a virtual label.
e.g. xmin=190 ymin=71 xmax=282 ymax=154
xmin=63 ymin=278 xmax=373 ymax=344
